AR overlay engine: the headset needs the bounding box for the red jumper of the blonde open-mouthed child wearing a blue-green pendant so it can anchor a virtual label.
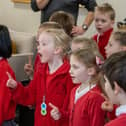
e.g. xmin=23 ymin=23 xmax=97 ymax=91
xmin=12 ymin=61 xmax=73 ymax=126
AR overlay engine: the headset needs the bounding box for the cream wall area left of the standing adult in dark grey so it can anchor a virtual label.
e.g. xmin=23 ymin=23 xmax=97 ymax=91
xmin=0 ymin=0 xmax=40 ymax=33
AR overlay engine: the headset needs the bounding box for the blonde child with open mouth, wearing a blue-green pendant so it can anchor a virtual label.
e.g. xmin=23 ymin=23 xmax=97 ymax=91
xmin=7 ymin=29 xmax=73 ymax=126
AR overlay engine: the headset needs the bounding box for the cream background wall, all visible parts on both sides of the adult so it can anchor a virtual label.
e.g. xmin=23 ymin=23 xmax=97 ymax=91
xmin=0 ymin=0 xmax=126 ymax=36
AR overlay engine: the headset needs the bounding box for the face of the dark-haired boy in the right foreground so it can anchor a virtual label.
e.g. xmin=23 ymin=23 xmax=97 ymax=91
xmin=104 ymin=76 xmax=117 ymax=104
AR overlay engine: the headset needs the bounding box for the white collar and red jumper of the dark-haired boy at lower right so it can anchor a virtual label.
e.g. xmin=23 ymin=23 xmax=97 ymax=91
xmin=105 ymin=105 xmax=126 ymax=126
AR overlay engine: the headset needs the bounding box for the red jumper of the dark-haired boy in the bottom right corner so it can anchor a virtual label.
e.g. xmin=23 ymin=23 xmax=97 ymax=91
xmin=105 ymin=114 xmax=126 ymax=126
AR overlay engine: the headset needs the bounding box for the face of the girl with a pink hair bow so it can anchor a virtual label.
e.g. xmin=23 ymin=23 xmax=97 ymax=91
xmin=70 ymin=55 xmax=89 ymax=83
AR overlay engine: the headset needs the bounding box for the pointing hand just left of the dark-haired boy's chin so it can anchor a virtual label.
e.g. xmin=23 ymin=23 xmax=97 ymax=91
xmin=101 ymin=95 xmax=113 ymax=112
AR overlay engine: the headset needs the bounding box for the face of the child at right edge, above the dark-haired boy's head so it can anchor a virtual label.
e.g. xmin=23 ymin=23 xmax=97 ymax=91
xmin=105 ymin=36 xmax=122 ymax=58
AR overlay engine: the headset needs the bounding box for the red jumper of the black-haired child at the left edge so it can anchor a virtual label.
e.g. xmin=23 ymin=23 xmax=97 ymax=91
xmin=0 ymin=58 xmax=16 ymax=126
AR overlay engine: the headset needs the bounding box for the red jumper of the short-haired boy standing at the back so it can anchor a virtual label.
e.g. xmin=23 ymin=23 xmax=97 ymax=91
xmin=93 ymin=28 xmax=113 ymax=59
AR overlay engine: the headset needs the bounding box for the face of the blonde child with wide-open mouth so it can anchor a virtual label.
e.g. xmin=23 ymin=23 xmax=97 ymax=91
xmin=37 ymin=32 xmax=55 ymax=63
